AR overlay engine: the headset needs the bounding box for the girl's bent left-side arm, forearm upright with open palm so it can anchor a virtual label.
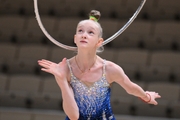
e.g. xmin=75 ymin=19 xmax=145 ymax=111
xmin=38 ymin=58 xmax=79 ymax=120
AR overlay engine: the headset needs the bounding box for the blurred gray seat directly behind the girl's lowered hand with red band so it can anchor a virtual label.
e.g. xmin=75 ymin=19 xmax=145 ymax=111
xmin=135 ymin=82 xmax=180 ymax=117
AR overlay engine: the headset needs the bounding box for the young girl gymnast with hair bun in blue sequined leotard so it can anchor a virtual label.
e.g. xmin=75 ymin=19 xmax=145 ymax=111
xmin=38 ymin=10 xmax=160 ymax=120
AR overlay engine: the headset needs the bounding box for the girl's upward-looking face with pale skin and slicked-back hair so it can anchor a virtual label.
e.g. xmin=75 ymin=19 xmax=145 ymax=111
xmin=74 ymin=20 xmax=103 ymax=49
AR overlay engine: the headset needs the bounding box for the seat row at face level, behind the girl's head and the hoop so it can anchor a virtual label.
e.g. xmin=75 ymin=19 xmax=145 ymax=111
xmin=0 ymin=16 xmax=180 ymax=50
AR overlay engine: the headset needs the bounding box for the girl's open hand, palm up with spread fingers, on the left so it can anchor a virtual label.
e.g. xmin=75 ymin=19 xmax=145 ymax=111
xmin=38 ymin=58 xmax=67 ymax=79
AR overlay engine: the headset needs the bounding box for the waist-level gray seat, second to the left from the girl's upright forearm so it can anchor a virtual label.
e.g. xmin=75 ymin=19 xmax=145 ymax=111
xmin=1 ymin=75 xmax=41 ymax=107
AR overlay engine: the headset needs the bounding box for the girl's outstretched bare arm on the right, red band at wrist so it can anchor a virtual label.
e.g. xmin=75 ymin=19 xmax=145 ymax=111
xmin=106 ymin=62 xmax=161 ymax=105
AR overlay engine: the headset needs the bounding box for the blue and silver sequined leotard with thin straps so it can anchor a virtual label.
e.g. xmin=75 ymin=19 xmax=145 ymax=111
xmin=66 ymin=60 xmax=115 ymax=120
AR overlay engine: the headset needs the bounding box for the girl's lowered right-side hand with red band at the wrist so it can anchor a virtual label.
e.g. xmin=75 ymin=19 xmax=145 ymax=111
xmin=143 ymin=91 xmax=161 ymax=105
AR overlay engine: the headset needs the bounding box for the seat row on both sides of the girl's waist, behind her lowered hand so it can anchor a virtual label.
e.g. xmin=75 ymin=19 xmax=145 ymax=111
xmin=0 ymin=74 xmax=180 ymax=118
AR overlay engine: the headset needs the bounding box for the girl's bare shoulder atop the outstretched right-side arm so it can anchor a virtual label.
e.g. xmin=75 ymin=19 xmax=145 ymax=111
xmin=106 ymin=61 xmax=125 ymax=83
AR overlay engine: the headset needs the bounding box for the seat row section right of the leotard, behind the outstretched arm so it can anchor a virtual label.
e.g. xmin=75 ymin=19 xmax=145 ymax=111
xmin=111 ymin=81 xmax=180 ymax=118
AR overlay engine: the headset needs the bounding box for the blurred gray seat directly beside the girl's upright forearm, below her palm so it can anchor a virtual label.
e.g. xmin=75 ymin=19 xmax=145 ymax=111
xmin=33 ymin=76 xmax=62 ymax=110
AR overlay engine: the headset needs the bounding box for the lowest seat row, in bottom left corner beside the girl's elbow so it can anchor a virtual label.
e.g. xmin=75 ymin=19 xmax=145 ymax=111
xmin=0 ymin=107 xmax=66 ymax=120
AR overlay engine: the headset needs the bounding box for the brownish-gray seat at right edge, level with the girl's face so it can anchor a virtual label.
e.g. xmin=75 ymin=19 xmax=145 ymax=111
xmin=146 ymin=20 xmax=180 ymax=50
